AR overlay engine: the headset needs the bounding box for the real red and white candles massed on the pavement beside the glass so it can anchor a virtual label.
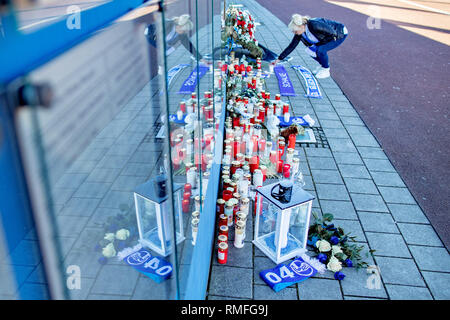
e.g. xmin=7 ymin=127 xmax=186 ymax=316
xmin=217 ymin=60 xmax=300 ymax=264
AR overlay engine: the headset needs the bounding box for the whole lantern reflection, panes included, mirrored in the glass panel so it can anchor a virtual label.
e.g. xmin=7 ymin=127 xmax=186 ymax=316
xmin=134 ymin=177 xmax=185 ymax=257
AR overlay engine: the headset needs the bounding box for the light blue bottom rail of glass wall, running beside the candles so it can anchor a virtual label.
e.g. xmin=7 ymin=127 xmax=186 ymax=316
xmin=183 ymin=92 xmax=226 ymax=300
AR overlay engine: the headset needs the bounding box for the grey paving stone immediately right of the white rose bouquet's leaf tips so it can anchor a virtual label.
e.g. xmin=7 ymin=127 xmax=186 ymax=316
xmin=366 ymin=232 xmax=411 ymax=258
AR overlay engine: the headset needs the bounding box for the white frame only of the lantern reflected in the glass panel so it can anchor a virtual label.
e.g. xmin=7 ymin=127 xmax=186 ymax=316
xmin=134 ymin=179 xmax=185 ymax=257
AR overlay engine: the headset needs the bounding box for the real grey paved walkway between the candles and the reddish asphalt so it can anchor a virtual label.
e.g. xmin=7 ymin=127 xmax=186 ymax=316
xmin=208 ymin=0 xmax=450 ymax=300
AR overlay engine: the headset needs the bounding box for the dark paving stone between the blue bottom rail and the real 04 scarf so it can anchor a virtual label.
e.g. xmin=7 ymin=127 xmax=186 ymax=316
xmin=209 ymin=265 xmax=251 ymax=299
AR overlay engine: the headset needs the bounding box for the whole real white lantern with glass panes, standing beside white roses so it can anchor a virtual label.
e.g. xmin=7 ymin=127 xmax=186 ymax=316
xmin=253 ymin=183 xmax=314 ymax=264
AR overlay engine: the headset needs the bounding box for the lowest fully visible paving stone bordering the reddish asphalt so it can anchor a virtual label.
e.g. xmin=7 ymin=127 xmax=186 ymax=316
xmin=398 ymin=223 xmax=442 ymax=247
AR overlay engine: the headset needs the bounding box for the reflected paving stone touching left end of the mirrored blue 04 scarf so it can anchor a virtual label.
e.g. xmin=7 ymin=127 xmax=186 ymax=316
xmin=91 ymin=265 xmax=139 ymax=296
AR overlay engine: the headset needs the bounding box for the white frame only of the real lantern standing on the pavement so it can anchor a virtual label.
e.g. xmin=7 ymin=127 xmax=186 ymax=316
xmin=253 ymin=183 xmax=315 ymax=264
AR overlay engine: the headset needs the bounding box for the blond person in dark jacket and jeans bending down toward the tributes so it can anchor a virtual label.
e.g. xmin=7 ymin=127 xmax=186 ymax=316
xmin=274 ymin=14 xmax=348 ymax=79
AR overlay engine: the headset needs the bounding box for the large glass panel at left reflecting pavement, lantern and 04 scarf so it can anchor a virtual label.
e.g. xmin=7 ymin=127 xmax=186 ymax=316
xmin=14 ymin=4 xmax=183 ymax=299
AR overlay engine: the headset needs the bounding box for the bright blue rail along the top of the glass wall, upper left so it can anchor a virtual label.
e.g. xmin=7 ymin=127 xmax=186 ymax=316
xmin=0 ymin=0 xmax=159 ymax=84
